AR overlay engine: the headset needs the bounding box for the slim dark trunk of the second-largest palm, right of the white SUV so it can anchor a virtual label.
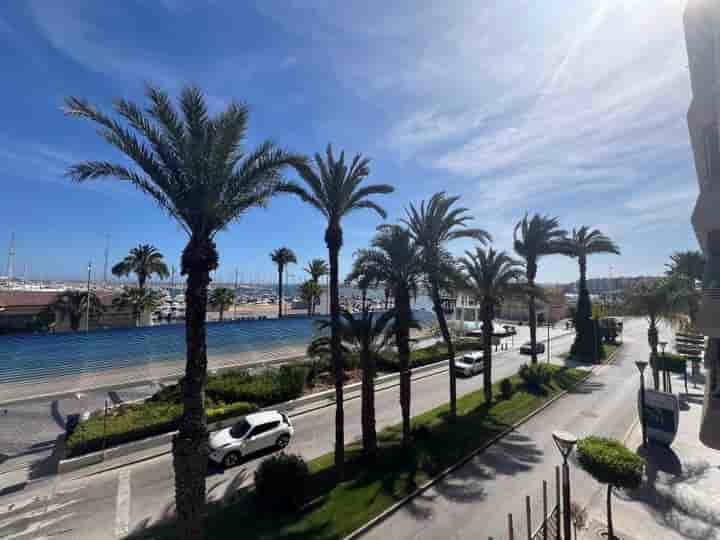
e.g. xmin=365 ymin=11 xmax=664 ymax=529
xmin=325 ymin=225 xmax=345 ymax=481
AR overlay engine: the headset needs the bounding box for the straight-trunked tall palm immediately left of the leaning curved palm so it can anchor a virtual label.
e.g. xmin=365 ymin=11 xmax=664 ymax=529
xmin=355 ymin=225 xmax=423 ymax=444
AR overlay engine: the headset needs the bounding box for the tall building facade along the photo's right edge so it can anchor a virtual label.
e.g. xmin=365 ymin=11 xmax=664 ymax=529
xmin=684 ymin=0 xmax=720 ymax=449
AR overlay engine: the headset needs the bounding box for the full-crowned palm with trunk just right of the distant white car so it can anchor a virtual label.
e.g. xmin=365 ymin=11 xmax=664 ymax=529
xmin=460 ymin=247 xmax=525 ymax=403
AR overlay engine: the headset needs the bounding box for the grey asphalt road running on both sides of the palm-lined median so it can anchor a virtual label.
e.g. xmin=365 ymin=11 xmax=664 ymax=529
xmin=0 ymin=321 xmax=646 ymax=540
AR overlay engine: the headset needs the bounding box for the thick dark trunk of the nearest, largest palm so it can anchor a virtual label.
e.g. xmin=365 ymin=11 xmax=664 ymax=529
xmin=173 ymin=237 xmax=217 ymax=540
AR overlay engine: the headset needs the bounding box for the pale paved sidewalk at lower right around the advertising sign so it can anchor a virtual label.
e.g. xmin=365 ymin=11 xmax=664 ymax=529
xmin=579 ymin=376 xmax=720 ymax=540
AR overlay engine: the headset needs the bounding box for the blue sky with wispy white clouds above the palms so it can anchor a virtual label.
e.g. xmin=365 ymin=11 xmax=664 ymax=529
xmin=0 ymin=0 xmax=697 ymax=282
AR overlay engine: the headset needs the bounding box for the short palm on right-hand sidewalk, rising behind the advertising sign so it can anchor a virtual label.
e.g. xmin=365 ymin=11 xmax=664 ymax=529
xmin=626 ymin=278 xmax=684 ymax=390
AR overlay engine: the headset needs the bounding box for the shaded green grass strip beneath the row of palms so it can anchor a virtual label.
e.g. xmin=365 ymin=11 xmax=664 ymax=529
xmin=133 ymin=365 xmax=589 ymax=540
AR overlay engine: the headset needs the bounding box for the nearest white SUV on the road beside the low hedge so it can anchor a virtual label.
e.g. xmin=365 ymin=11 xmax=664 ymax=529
xmin=210 ymin=411 xmax=294 ymax=467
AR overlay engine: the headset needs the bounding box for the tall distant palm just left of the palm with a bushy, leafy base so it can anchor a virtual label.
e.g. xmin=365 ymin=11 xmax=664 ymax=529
xmin=513 ymin=214 xmax=567 ymax=364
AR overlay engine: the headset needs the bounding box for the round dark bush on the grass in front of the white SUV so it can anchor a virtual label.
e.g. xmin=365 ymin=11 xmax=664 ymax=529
xmin=255 ymin=452 xmax=310 ymax=512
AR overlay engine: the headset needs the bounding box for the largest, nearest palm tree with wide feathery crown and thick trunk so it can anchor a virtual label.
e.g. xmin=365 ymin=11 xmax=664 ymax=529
xmin=65 ymin=86 xmax=305 ymax=539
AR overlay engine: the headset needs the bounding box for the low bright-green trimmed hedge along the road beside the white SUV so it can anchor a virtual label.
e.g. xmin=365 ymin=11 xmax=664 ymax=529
xmin=65 ymin=402 xmax=258 ymax=457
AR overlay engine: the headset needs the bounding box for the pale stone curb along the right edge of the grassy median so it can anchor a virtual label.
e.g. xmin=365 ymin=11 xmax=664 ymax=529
xmin=343 ymin=347 xmax=620 ymax=540
